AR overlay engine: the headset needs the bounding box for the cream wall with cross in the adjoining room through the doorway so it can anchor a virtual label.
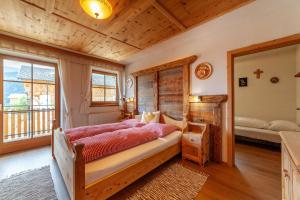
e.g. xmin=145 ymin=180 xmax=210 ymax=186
xmin=234 ymin=45 xmax=296 ymax=122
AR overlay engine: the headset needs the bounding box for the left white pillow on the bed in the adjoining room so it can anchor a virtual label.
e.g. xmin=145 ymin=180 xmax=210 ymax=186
xmin=234 ymin=117 xmax=269 ymax=129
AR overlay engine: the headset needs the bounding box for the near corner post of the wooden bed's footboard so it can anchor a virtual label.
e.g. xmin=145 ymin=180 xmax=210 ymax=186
xmin=74 ymin=143 xmax=85 ymax=200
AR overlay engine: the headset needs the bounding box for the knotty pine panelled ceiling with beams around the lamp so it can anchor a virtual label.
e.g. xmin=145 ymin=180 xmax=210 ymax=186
xmin=0 ymin=0 xmax=253 ymax=61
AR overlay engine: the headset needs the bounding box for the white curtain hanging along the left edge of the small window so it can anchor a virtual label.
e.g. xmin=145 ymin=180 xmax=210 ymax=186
xmin=80 ymin=65 xmax=92 ymax=114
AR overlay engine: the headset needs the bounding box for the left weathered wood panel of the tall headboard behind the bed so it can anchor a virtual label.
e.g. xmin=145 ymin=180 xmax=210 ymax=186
xmin=137 ymin=73 xmax=156 ymax=113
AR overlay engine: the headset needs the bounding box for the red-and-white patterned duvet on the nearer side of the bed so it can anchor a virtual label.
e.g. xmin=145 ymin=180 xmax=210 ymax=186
xmin=74 ymin=123 xmax=178 ymax=163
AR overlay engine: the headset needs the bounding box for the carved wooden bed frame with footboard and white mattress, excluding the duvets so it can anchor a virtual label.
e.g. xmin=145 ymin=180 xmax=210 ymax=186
xmin=52 ymin=115 xmax=186 ymax=200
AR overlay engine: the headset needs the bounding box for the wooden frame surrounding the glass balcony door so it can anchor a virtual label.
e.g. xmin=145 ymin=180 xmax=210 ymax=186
xmin=0 ymin=54 xmax=60 ymax=155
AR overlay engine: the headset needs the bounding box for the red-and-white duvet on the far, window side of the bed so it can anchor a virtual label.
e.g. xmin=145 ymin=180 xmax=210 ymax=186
xmin=65 ymin=119 xmax=145 ymax=143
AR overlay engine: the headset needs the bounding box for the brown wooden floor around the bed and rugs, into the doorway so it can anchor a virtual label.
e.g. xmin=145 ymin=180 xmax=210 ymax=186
xmin=0 ymin=144 xmax=281 ymax=200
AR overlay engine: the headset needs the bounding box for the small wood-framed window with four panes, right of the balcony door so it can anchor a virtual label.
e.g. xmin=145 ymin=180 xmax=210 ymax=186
xmin=91 ymin=70 xmax=118 ymax=106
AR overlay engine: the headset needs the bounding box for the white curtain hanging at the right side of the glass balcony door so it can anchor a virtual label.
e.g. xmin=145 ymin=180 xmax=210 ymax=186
xmin=58 ymin=59 xmax=73 ymax=129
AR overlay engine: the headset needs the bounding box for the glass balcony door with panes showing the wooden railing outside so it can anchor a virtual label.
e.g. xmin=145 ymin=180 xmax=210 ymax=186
xmin=0 ymin=56 xmax=59 ymax=150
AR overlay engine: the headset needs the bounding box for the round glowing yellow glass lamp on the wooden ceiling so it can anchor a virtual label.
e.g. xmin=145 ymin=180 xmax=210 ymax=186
xmin=80 ymin=0 xmax=112 ymax=19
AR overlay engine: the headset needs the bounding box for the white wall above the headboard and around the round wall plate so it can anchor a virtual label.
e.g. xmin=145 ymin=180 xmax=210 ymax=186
xmin=124 ymin=0 xmax=300 ymax=161
